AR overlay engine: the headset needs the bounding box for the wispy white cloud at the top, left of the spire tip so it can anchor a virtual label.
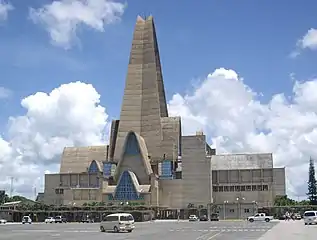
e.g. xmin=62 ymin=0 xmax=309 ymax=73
xmin=29 ymin=0 xmax=125 ymax=49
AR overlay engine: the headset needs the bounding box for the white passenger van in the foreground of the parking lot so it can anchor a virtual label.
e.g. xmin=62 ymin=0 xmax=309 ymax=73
xmin=100 ymin=213 xmax=134 ymax=232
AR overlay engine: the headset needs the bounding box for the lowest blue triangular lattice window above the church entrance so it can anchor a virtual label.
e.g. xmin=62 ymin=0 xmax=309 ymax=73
xmin=114 ymin=171 xmax=143 ymax=201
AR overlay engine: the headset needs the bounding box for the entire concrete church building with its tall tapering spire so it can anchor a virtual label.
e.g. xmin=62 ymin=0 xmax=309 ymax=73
xmin=44 ymin=16 xmax=286 ymax=209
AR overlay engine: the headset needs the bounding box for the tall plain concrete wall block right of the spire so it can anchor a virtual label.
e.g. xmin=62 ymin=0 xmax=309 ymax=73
xmin=182 ymin=135 xmax=212 ymax=207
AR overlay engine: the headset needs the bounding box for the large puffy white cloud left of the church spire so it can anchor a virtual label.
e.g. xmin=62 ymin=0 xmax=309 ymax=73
xmin=0 ymin=82 xmax=108 ymax=196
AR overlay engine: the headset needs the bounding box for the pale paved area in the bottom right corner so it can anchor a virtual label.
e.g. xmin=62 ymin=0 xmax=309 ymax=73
xmin=258 ymin=221 xmax=317 ymax=240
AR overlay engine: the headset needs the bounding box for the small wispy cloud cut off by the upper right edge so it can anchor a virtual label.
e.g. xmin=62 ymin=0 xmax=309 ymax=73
xmin=290 ymin=28 xmax=317 ymax=58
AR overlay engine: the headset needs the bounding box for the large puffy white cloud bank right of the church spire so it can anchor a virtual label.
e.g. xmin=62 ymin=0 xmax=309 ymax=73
xmin=169 ymin=68 xmax=317 ymax=199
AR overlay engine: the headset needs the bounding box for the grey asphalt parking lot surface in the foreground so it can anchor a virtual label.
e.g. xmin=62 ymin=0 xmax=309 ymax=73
xmin=0 ymin=221 xmax=302 ymax=240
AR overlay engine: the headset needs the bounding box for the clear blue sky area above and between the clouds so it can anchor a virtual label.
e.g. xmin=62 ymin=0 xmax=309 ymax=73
xmin=0 ymin=0 xmax=317 ymax=124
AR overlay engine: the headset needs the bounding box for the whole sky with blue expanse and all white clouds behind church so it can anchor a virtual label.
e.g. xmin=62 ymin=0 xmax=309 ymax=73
xmin=0 ymin=0 xmax=317 ymax=197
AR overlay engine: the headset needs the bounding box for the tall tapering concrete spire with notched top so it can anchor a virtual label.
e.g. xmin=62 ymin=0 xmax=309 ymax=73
xmin=115 ymin=16 xmax=168 ymax=160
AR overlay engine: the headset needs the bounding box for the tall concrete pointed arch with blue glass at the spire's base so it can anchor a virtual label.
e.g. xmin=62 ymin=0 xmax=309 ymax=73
xmin=115 ymin=131 xmax=153 ymax=179
